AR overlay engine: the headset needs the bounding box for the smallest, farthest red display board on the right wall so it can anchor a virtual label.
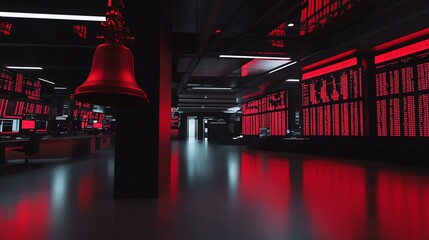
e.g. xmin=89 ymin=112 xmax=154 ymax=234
xmin=242 ymin=91 xmax=288 ymax=136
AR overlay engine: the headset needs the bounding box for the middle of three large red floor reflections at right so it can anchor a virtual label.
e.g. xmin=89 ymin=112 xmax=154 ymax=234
xmin=303 ymin=160 xmax=366 ymax=240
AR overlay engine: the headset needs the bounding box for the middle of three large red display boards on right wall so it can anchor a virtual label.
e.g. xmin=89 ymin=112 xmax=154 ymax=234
xmin=301 ymin=57 xmax=364 ymax=136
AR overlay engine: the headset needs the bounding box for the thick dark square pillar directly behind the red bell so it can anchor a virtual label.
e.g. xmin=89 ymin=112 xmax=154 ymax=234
xmin=114 ymin=0 xmax=171 ymax=198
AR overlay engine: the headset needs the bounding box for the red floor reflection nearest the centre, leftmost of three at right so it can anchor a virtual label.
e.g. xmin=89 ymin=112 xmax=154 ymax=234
xmin=240 ymin=152 xmax=291 ymax=231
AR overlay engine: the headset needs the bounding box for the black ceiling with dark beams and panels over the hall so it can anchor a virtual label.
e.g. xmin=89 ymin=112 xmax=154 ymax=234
xmin=0 ymin=0 xmax=429 ymax=111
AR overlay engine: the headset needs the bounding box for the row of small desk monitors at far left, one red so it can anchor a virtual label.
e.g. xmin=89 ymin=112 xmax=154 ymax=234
xmin=0 ymin=118 xmax=48 ymax=135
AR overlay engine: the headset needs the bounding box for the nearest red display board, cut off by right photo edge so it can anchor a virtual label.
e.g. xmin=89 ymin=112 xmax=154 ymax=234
xmin=374 ymin=39 xmax=429 ymax=137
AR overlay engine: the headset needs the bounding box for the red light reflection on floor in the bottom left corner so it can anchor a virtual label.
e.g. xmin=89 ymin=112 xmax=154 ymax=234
xmin=0 ymin=192 xmax=49 ymax=240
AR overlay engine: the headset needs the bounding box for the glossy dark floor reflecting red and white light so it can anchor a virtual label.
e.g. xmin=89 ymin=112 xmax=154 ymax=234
xmin=0 ymin=141 xmax=429 ymax=240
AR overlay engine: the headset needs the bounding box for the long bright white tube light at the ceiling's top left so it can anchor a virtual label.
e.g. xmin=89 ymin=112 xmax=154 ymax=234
xmin=0 ymin=12 xmax=106 ymax=22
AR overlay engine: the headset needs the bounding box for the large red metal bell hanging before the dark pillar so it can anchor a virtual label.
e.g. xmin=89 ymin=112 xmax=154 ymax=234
xmin=74 ymin=43 xmax=149 ymax=107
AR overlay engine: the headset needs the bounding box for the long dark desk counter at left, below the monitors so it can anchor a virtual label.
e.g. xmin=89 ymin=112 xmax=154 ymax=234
xmin=0 ymin=135 xmax=113 ymax=165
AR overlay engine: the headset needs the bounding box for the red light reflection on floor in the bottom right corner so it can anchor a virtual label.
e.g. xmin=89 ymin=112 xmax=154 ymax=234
xmin=377 ymin=171 xmax=429 ymax=240
